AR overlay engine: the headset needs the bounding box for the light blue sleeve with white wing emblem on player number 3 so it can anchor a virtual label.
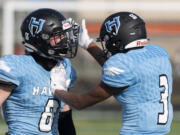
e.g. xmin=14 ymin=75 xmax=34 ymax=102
xmin=102 ymin=55 xmax=136 ymax=88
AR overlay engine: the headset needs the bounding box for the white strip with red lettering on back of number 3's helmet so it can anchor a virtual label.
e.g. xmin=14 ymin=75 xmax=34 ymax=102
xmin=125 ymin=39 xmax=148 ymax=49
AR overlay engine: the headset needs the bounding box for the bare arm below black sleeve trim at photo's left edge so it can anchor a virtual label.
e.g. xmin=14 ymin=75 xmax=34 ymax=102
xmin=0 ymin=81 xmax=16 ymax=107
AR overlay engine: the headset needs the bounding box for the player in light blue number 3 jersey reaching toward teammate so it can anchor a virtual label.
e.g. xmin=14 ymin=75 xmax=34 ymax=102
xmin=55 ymin=12 xmax=173 ymax=135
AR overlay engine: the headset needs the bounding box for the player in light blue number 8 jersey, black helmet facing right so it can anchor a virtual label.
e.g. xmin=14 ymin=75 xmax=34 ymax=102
xmin=0 ymin=8 xmax=79 ymax=135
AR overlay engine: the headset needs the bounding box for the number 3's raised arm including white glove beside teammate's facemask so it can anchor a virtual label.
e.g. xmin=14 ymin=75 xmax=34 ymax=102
xmin=79 ymin=19 xmax=106 ymax=66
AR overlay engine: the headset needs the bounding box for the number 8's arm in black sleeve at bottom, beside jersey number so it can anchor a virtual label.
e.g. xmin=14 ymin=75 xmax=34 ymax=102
xmin=58 ymin=105 xmax=76 ymax=135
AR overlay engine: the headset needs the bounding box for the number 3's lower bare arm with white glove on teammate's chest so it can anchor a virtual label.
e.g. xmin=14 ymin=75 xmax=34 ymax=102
xmin=52 ymin=64 xmax=127 ymax=109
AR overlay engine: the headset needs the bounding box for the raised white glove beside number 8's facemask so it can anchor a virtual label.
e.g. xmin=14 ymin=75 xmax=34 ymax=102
xmin=79 ymin=19 xmax=93 ymax=49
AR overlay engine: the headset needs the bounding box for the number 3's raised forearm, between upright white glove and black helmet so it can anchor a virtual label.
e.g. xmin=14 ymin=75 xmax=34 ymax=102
xmin=87 ymin=42 xmax=106 ymax=66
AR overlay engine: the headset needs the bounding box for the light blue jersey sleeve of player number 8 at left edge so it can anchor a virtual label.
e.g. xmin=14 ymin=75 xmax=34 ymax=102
xmin=0 ymin=55 xmax=20 ymax=86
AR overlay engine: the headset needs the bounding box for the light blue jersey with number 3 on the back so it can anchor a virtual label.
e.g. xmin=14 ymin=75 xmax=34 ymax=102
xmin=102 ymin=44 xmax=173 ymax=135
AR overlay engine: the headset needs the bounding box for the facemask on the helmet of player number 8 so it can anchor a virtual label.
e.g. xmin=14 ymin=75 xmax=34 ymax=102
xmin=48 ymin=22 xmax=79 ymax=58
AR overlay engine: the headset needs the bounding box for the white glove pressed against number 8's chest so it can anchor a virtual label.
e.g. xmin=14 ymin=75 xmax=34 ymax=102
xmin=50 ymin=64 xmax=68 ymax=94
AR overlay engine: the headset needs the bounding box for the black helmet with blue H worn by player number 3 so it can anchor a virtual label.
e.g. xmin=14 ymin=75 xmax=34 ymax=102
xmin=97 ymin=12 xmax=147 ymax=56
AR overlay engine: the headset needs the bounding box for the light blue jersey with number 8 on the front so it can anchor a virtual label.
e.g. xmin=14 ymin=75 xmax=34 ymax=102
xmin=0 ymin=55 xmax=76 ymax=135
